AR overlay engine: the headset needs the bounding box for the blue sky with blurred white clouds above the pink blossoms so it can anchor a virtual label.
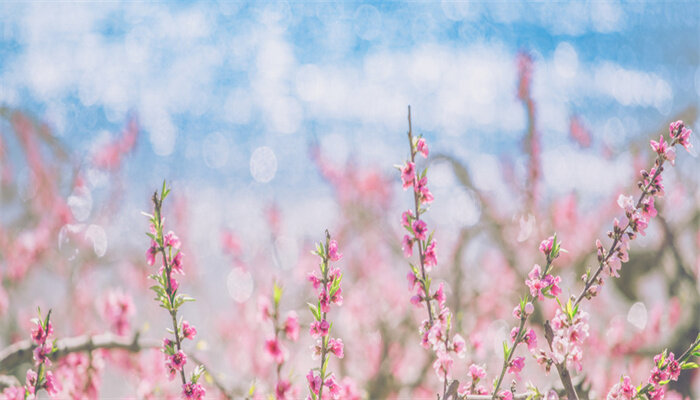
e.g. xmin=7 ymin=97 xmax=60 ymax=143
xmin=0 ymin=1 xmax=700 ymax=231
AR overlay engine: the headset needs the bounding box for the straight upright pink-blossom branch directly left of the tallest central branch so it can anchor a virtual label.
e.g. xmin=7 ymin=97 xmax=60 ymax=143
xmin=306 ymin=231 xmax=344 ymax=400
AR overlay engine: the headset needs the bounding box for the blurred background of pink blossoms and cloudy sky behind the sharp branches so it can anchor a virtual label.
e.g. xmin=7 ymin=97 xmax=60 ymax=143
xmin=0 ymin=1 xmax=700 ymax=399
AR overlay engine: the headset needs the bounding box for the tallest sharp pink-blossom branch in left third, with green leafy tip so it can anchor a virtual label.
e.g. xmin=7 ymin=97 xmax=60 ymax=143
xmin=146 ymin=182 xmax=206 ymax=400
